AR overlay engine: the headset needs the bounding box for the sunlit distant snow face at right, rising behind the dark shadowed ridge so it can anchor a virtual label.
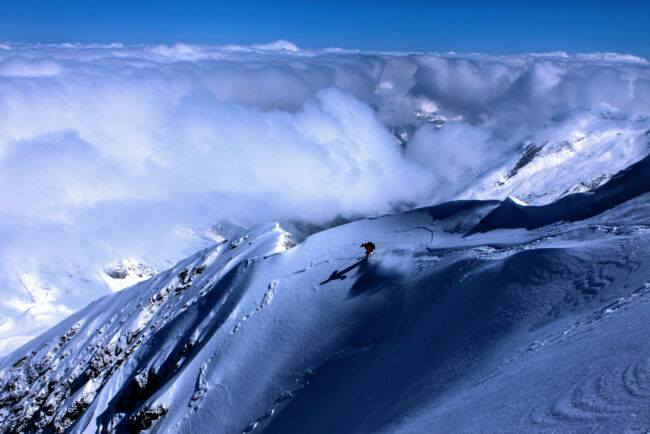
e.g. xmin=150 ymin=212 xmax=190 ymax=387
xmin=459 ymin=120 xmax=650 ymax=205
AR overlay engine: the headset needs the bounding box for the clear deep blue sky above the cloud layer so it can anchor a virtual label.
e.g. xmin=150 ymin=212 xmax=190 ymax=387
xmin=0 ymin=0 xmax=650 ymax=58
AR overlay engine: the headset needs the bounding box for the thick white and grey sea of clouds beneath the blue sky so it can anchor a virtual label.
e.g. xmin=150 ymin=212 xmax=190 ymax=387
xmin=0 ymin=41 xmax=650 ymax=352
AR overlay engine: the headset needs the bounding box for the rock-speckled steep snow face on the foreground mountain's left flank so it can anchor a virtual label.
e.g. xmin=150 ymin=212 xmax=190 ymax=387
xmin=0 ymin=225 xmax=293 ymax=431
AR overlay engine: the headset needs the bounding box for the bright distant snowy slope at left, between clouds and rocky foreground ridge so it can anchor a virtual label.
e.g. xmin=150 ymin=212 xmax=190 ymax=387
xmin=0 ymin=222 xmax=242 ymax=355
